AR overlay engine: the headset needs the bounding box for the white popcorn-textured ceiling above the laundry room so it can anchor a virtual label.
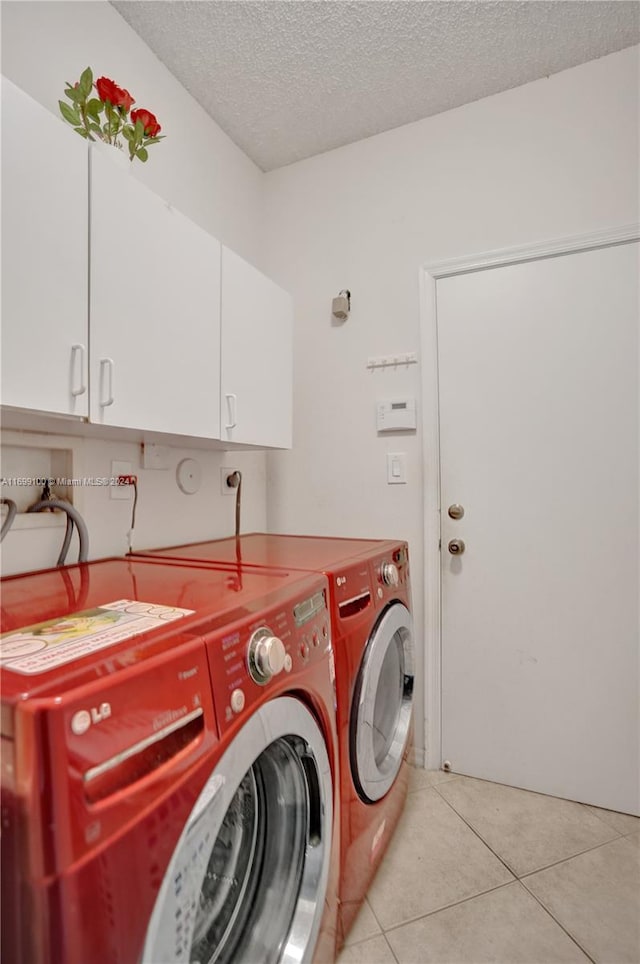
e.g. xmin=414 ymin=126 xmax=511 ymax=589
xmin=112 ymin=0 xmax=640 ymax=171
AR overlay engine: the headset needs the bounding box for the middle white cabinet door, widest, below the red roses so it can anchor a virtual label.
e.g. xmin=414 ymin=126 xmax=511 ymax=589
xmin=90 ymin=148 xmax=220 ymax=438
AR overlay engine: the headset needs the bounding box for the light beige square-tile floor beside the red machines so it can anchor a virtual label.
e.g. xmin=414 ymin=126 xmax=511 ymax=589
xmin=339 ymin=770 xmax=640 ymax=964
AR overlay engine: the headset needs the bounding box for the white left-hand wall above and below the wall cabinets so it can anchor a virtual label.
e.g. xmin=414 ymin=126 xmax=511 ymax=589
xmin=1 ymin=0 xmax=266 ymax=573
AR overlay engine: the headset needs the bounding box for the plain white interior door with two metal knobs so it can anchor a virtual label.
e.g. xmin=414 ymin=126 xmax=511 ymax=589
xmin=436 ymin=242 xmax=639 ymax=813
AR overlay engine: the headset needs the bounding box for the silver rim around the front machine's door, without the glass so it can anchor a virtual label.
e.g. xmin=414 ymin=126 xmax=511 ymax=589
xmin=141 ymin=696 xmax=333 ymax=964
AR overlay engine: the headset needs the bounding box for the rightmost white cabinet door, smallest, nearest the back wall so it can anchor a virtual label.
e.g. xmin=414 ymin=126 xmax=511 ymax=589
xmin=220 ymin=247 xmax=293 ymax=448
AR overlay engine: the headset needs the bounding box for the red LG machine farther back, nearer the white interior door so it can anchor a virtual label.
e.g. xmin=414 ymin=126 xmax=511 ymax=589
xmin=135 ymin=533 xmax=414 ymax=945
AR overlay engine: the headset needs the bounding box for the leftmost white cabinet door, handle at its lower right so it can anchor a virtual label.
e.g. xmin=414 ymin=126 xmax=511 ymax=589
xmin=2 ymin=78 xmax=89 ymax=416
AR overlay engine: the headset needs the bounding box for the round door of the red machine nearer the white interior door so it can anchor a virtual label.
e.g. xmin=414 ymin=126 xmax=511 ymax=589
xmin=350 ymin=602 xmax=413 ymax=803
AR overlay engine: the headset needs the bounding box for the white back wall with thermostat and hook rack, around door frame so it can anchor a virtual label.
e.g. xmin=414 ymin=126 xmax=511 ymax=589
xmin=264 ymin=48 xmax=638 ymax=760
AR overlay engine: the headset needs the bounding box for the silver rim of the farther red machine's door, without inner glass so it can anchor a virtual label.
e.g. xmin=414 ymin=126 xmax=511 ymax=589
xmin=351 ymin=602 xmax=413 ymax=803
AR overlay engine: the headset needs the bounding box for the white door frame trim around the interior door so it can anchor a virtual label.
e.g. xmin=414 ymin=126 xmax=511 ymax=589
xmin=419 ymin=222 xmax=640 ymax=769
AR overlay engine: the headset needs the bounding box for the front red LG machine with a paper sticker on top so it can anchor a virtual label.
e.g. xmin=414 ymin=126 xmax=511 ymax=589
xmin=0 ymin=558 xmax=340 ymax=964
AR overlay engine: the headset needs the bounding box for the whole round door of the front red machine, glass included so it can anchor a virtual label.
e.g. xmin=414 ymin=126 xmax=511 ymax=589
xmin=142 ymin=697 xmax=333 ymax=964
